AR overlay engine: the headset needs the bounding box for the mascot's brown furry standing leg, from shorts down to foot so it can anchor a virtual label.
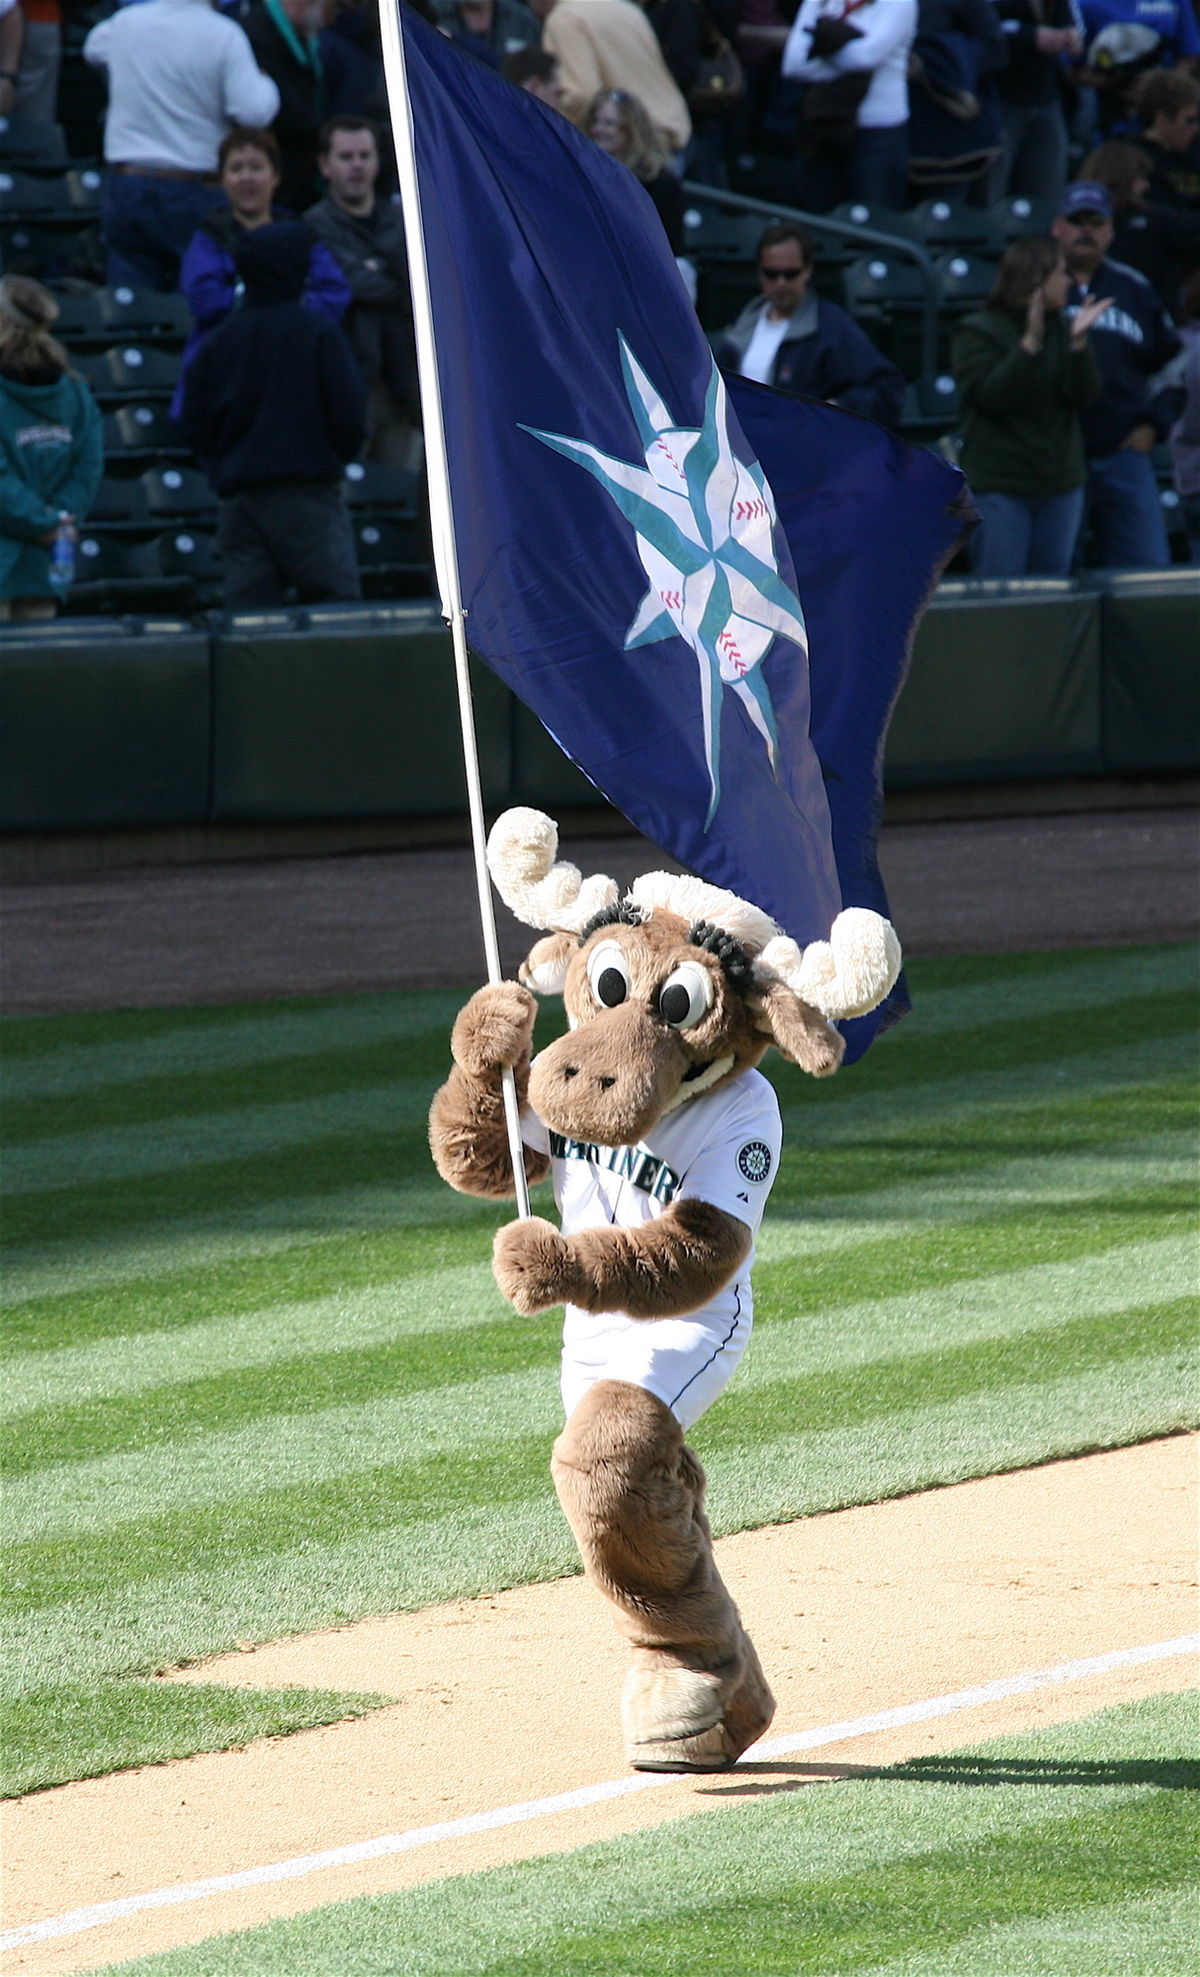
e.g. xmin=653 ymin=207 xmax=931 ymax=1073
xmin=552 ymin=1380 xmax=775 ymax=1771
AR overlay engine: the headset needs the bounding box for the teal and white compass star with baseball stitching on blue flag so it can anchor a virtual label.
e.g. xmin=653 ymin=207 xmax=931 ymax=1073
xmin=524 ymin=338 xmax=809 ymax=830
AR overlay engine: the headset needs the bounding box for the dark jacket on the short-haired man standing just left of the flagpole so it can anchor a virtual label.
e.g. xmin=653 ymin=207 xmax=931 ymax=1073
xmin=304 ymin=198 xmax=419 ymax=423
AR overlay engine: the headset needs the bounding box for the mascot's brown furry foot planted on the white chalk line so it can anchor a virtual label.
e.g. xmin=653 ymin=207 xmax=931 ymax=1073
xmin=621 ymin=1641 xmax=775 ymax=1771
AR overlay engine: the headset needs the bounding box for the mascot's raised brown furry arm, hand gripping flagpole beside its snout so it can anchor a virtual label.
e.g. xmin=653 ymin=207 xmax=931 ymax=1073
xmin=429 ymin=983 xmax=550 ymax=1196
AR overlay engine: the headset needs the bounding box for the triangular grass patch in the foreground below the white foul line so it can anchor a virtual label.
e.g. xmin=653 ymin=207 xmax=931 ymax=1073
xmin=91 ymin=1696 xmax=1200 ymax=1977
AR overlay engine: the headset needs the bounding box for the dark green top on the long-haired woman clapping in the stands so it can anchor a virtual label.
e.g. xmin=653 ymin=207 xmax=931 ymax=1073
xmin=951 ymin=308 xmax=1101 ymax=500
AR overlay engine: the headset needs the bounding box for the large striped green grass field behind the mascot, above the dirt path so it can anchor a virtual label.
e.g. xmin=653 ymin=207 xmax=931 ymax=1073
xmin=4 ymin=947 xmax=1196 ymax=1791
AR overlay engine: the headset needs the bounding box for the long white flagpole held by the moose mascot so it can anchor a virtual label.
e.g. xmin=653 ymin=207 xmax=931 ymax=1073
xmin=380 ymin=0 xmax=530 ymax=1220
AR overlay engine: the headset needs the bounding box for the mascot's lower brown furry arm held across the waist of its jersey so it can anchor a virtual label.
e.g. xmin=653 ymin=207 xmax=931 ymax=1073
xmin=492 ymin=1196 xmax=751 ymax=1319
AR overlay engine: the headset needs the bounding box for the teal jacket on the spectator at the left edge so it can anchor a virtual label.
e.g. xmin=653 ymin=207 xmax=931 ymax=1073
xmin=0 ymin=374 xmax=105 ymax=597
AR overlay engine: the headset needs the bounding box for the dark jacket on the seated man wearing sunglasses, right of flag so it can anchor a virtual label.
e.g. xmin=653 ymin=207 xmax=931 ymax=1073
xmin=712 ymin=293 xmax=903 ymax=425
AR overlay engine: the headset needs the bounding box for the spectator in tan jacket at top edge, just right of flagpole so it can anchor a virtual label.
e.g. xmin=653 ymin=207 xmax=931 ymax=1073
xmin=542 ymin=0 xmax=692 ymax=156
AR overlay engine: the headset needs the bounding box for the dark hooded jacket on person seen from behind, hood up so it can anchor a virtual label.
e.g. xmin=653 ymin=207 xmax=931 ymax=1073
xmin=180 ymin=221 xmax=366 ymax=494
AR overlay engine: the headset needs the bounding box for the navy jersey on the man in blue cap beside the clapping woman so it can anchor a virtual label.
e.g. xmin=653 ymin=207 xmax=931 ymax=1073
xmin=1066 ymin=261 xmax=1182 ymax=459
